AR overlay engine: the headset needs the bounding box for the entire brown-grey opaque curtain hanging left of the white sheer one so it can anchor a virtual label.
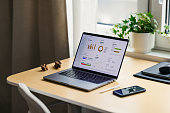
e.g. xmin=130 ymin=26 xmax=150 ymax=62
xmin=0 ymin=0 xmax=69 ymax=113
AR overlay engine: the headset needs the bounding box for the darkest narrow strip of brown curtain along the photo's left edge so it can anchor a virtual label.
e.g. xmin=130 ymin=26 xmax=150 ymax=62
xmin=0 ymin=0 xmax=12 ymax=113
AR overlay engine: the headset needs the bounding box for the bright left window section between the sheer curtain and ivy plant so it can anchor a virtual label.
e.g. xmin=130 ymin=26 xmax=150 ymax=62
xmin=96 ymin=0 xmax=148 ymax=36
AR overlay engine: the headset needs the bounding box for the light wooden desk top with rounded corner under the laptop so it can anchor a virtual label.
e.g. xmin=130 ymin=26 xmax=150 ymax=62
xmin=7 ymin=57 xmax=170 ymax=113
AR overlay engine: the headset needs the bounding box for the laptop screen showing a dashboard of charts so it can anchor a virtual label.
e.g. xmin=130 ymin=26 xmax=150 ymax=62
xmin=73 ymin=33 xmax=128 ymax=77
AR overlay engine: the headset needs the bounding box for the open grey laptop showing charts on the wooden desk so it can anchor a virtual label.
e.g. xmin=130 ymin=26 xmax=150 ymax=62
xmin=43 ymin=32 xmax=129 ymax=91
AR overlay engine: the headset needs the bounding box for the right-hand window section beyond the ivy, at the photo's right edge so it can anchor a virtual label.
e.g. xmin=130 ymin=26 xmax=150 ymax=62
xmin=150 ymin=0 xmax=170 ymax=51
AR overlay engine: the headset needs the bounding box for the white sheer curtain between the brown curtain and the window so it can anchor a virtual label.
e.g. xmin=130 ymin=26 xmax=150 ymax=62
xmin=72 ymin=0 xmax=98 ymax=54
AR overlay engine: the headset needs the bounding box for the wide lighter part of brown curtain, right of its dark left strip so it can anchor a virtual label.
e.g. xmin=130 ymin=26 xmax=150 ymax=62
xmin=12 ymin=0 xmax=69 ymax=73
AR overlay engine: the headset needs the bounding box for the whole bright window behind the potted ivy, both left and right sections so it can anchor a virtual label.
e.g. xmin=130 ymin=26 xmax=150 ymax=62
xmin=96 ymin=0 xmax=170 ymax=51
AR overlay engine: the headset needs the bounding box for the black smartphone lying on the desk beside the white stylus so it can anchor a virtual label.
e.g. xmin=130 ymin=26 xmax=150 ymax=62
xmin=113 ymin=86 xmax=146 ymax=97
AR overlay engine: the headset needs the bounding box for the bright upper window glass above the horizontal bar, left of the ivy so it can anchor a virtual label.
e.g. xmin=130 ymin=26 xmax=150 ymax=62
xmin=97 ymin=0 xmax=138 ymax=24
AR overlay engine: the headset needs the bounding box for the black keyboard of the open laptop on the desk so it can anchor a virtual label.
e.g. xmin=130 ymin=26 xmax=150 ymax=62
xmin=59 ymin=70 xmax=112 ymax=84
